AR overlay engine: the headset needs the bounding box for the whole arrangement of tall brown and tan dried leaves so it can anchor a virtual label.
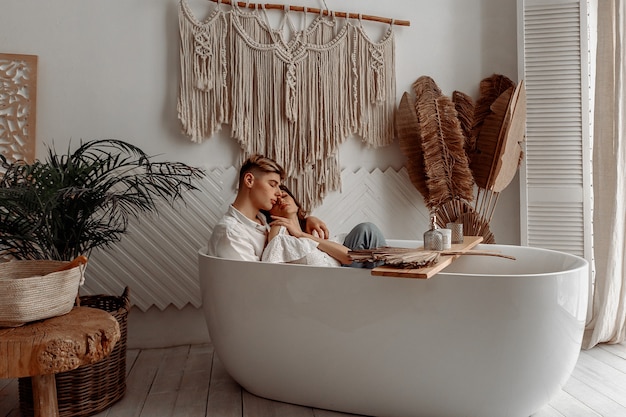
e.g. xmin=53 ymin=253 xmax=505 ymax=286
xmin=396 ymin=75 xmax=526 ymax=243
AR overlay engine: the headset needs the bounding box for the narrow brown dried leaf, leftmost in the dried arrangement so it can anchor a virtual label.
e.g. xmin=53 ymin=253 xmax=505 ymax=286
xmin=396 ymin=92 xmax=428 ymax=200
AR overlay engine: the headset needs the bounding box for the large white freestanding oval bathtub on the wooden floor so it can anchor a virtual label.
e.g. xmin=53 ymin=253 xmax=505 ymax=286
xmin=199 ymin=241 xmax=588 ymax=417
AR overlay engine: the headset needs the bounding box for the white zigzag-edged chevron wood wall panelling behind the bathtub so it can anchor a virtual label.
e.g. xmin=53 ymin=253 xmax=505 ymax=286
xmin=81 ymin=167 xmax=428 ymax=311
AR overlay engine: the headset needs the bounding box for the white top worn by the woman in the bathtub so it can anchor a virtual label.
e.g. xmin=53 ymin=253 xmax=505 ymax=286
xmin=261 ymin=226 xmax=341 ymax=266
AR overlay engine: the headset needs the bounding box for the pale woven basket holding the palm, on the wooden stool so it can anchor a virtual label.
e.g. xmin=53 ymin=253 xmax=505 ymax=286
xmin=0 ymin=260 xmax=84 ymax=327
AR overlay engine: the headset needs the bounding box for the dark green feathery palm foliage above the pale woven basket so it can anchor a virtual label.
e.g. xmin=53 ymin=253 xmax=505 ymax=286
xmin=0 ymin=139 xmax=204 ymax=260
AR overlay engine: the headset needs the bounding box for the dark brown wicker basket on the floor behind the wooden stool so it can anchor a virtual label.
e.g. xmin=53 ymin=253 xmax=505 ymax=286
xmin=19 ymin=287 xmax=130 ymax=417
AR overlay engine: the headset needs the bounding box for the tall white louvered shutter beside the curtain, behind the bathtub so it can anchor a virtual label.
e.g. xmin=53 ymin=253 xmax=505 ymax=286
xmin=518 ymin=0 xmax=593 ymax=261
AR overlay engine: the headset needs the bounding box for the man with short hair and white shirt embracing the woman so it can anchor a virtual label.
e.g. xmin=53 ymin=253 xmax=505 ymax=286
xmin=207 ymin=155 xmax=328 ymax=261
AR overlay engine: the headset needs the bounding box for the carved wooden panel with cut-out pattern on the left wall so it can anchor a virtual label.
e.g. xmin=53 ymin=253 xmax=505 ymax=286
xmin=0 ymin=54 xmax=37 ymax=162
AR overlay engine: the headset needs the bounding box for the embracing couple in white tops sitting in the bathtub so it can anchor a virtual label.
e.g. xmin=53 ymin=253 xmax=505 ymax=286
xmin=208 ymin=155 xmax=386 ymax=267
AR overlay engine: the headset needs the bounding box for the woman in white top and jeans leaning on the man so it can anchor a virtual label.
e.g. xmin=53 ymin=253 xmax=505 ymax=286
xmin=261 ymin=186 xmax=386 ymax=267
